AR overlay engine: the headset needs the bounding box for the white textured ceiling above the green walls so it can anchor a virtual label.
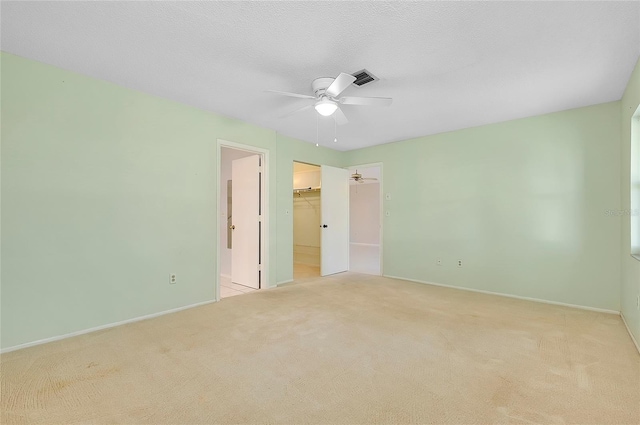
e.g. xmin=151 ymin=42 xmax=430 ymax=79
xmin=1 ymin=1 xmax=640 ymax=150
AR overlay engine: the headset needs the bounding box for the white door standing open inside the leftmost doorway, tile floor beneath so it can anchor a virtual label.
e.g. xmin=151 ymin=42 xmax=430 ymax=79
xmin=231 ymin=155 xmax=260 ymax=289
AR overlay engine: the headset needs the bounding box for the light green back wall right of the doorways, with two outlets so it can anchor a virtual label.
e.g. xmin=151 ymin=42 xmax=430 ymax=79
xmin=346 ymin=102 xmax=620 ymax=311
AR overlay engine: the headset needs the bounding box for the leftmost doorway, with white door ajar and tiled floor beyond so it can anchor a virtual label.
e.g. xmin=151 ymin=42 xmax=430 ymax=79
xmin=216 ymin=140 xmax=268 ymax=300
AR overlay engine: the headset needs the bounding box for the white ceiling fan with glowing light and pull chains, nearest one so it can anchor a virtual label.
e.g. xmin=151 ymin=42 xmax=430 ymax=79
xmin=267 ymin=72 xmax=393 ymax=125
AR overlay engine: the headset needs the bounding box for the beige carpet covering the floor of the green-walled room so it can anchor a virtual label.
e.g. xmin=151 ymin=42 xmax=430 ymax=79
xmin=0 ymin=273 xmax=640 ymax=424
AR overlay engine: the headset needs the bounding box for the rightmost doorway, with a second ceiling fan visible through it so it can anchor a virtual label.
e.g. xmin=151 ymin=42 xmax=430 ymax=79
xmin=349 ymin=164 xmax=382 ymax=275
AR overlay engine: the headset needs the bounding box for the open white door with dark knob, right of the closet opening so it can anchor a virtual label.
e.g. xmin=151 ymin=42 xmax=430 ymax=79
xmin=320 ymin=165 xmax=349 ymax=276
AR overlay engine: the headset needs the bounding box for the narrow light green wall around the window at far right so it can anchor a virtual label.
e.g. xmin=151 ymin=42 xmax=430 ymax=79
xmin=618 ymin=55 xmax=640 ymax=344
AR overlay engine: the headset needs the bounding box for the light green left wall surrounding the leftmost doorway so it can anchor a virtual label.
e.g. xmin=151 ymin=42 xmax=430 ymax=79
xmin=0 ymin=53 xmax=340 ymax=348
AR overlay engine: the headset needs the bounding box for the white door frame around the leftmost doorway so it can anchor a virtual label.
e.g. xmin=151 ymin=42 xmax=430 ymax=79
xmin=215 ymin=139 xmax=270 ymax=301
